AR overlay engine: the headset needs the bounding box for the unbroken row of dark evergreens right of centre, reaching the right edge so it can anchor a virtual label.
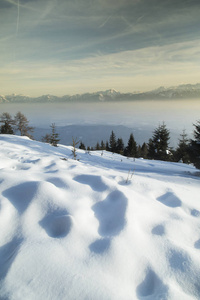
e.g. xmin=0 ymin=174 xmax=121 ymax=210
xmin=79 ymin=120 xmax=200 ymax=169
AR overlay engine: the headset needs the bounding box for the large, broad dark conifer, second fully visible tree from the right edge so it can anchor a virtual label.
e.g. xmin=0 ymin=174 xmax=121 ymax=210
xmin=151 ymin=122 xmax=170 ymax=160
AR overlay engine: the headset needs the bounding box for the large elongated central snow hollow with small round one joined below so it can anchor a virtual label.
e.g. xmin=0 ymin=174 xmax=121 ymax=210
xmin=89 ymin=190 xmax=127 ymax=253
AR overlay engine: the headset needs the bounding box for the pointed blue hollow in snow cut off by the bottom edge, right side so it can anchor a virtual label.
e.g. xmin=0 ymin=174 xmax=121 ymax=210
xmin=136 ymin=268 xmax=168 ymax=300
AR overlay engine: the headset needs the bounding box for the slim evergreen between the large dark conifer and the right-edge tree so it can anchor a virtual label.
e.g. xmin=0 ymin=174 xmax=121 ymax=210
xmin=174 ymin=130 xmax=190 ymax=164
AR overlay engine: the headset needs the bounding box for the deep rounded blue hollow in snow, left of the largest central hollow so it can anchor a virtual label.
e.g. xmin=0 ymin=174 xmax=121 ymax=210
xmin=39 ymin=212 xmax=72 ymax=238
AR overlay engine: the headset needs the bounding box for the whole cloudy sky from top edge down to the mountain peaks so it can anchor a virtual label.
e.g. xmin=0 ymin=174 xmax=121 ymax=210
xmin=0 ymin=0 xmax=200 ymax=96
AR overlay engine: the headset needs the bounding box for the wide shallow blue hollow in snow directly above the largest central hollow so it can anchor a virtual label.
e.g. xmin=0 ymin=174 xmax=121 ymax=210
xmin=74 ymin=175 xmax=107 ymax=192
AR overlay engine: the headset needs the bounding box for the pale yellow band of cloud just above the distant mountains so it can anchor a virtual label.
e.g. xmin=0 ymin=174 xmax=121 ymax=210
xmin=0 ymin=40 xmax=200 ymax=86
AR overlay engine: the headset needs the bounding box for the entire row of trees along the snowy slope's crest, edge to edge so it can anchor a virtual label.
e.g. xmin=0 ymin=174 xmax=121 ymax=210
xmin=0 ymin=112 xmax=200 ymax=169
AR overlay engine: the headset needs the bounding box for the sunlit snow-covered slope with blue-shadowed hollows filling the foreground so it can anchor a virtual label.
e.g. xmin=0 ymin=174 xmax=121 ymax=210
xmin=0 ymin=135 xmax=200 ymax=300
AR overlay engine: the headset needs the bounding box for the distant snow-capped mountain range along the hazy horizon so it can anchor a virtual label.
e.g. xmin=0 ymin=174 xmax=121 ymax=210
xmin=0 ymin=83 xmax=200 ymax=103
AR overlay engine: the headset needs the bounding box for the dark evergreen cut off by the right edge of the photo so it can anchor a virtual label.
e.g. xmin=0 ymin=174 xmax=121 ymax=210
xmin=190 ymin=120 xmax=200 ymax=169
